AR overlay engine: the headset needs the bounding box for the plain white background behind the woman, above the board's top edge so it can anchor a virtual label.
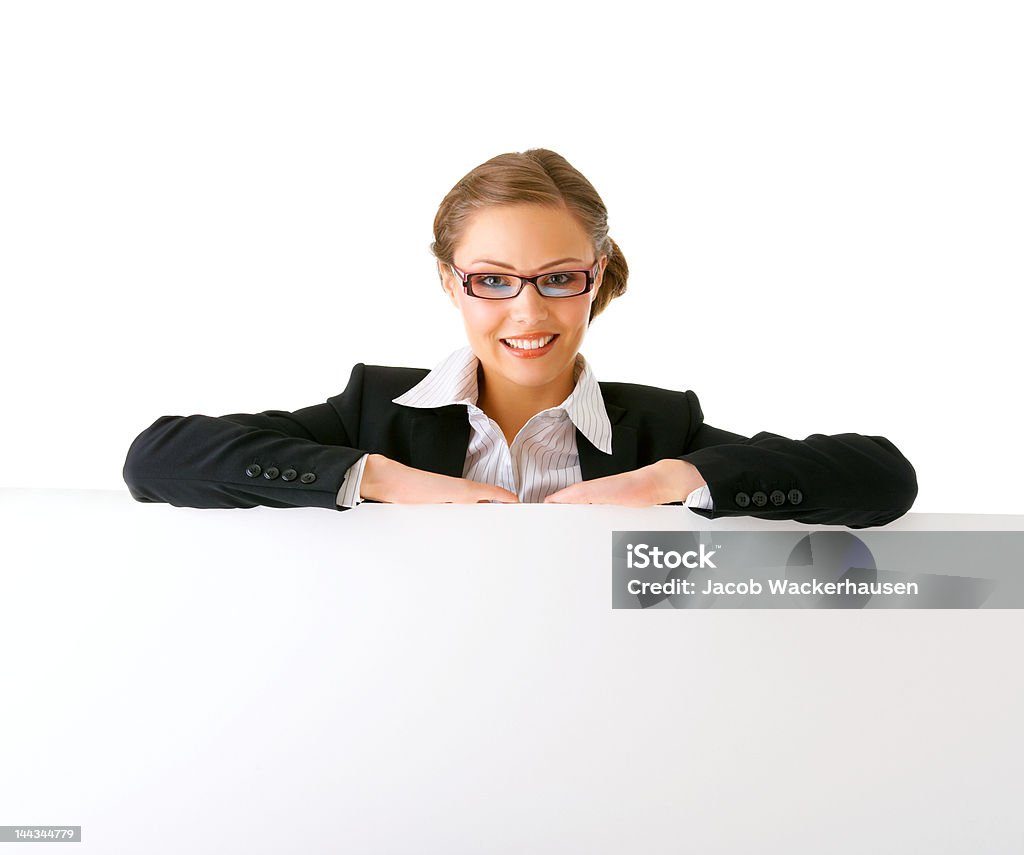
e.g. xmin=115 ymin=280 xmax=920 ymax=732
xmin=0 ymin=0 xmax=1024 ymax=513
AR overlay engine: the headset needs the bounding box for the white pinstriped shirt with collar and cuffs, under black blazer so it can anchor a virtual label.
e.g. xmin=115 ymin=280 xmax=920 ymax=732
xmin=337 ymin=345 xmax=714 ymax=509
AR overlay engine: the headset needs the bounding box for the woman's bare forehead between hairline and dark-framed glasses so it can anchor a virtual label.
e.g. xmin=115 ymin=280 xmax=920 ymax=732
xmin=456 ymin=205 xmax=593 ymax=267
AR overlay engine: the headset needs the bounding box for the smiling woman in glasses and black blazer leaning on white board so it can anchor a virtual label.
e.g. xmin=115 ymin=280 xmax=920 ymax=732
xmin=124 ymin=148 xmax=918 ymax=528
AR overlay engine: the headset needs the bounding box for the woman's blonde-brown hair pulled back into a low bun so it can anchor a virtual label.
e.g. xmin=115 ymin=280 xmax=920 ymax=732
xmin=430 ymin=148 xmax=630 ymax=320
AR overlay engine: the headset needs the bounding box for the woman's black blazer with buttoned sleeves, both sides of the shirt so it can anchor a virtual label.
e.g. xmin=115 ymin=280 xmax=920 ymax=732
xmin=123 ymin=362 xmax=918 ymax=528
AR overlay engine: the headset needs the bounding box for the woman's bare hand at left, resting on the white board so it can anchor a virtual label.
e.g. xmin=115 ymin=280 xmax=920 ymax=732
xmin=359 ymin=455 xmax=519 ymax=505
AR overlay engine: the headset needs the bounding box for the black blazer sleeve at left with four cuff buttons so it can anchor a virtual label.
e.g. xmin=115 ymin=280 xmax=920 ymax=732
xmin=122 ymin=362 xmax=367 ymax=511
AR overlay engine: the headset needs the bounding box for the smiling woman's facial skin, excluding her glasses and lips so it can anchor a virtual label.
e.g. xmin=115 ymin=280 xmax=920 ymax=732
xmin=441 ymin=204 xmax=608 ymax=395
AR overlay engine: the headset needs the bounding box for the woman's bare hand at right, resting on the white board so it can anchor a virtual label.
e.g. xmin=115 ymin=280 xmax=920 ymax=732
xmin=544 ymin=459 xmax=707 ymax=508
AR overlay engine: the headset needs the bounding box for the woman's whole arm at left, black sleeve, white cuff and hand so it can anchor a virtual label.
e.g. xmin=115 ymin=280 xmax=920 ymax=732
xmin=123 ymin=364 xmax=518 ymax=511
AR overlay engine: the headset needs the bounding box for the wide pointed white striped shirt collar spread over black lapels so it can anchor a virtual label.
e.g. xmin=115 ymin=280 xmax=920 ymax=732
xmin=392 ymin=345 xmax=611 ymax=455
